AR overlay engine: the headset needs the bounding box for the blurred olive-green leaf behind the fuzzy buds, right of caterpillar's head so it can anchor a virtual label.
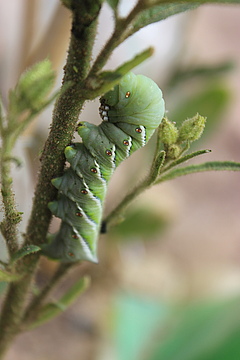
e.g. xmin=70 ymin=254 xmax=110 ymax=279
xmin=170 ymin=84 xmax=230 ymax=140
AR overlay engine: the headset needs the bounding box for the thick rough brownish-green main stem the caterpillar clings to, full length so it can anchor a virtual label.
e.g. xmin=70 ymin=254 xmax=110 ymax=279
xmin=0 ymin=2 xmax=101 ymax=359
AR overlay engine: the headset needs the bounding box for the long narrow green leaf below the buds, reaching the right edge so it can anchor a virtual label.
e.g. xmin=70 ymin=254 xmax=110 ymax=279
xmin=155 ymin=161 xmax=240 ymax=184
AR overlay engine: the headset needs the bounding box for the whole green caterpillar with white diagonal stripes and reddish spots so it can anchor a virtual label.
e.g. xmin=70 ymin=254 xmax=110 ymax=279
xmin=43 ymin=73 xmax=164 ymax=263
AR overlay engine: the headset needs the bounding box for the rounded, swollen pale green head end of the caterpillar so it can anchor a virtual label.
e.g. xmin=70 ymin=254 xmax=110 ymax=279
xmin=99 ymin=72 xmax=165 ymax=129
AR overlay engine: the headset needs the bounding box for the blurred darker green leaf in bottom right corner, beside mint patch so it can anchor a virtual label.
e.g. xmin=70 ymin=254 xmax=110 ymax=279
xmin=147 ymin=298 xmax=240 ymax=360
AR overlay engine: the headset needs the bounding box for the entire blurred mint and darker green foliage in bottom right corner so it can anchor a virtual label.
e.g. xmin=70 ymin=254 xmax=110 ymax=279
xmin=109 ymin=294 xmax=240 ymax=360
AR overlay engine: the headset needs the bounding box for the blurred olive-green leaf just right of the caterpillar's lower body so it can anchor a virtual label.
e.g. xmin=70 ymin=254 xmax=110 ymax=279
xmin=111 ymin=208 xmax=167 ymax=241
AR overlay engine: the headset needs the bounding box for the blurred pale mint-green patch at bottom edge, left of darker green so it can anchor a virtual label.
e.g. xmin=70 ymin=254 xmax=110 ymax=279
xmin=113 ymin=292 xmax=169 ymax=360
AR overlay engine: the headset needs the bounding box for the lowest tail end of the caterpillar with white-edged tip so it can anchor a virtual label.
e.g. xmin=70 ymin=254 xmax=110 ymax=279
xmin=41 ymin=232 xmax=98 ymax=264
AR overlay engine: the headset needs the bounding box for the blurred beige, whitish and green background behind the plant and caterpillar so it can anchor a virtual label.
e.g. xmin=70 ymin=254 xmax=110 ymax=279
xmin=0 ymin=0 xmax=240 ymax=360
